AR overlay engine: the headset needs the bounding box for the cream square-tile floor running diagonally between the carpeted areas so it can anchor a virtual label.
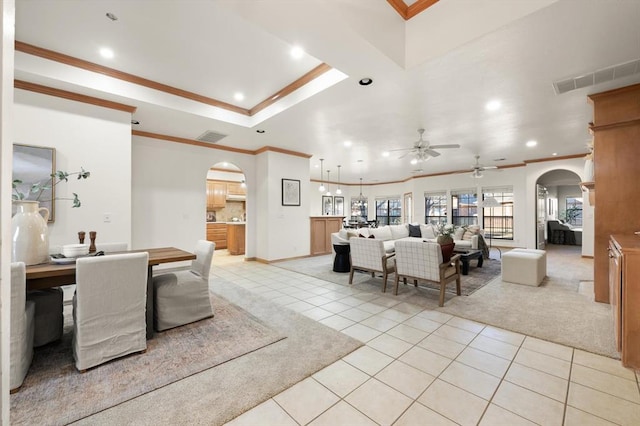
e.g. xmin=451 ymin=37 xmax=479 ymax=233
xmin=212 ymin=253 xmax=640 ymax=426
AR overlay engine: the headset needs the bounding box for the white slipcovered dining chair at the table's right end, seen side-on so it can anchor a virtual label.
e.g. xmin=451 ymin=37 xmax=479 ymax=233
xmin=153 ymin=240 xmax=216 ymax=331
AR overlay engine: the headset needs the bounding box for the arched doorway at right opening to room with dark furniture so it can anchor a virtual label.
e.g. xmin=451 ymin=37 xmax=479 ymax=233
xmin=536 ymin=169 xmax=583 ymax=254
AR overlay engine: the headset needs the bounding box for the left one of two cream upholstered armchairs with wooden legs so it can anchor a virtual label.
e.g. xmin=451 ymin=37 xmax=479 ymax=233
xmin=349 ymin=237 xmax=395 ymax=293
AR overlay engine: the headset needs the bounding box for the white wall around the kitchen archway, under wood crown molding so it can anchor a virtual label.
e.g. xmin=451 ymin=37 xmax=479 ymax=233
xmin=131 ymin=136 xmax=256 ymax=256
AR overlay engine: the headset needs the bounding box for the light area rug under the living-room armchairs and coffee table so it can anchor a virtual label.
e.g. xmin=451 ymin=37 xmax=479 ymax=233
xmin=272 ymin=255 xmax=501 ymax=296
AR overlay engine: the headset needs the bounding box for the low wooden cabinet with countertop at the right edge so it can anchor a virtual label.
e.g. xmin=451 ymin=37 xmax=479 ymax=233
xmin=608 ymin=234 xmax=640 ymax=369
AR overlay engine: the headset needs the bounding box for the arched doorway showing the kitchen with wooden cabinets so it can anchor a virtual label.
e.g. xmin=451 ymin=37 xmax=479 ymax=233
xmin=206 ymin=162 xmax=247 ymax=263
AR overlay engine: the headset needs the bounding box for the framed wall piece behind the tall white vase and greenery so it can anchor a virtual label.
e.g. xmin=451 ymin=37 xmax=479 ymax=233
xmin=12 ymin=144 xmax=56 ymax=222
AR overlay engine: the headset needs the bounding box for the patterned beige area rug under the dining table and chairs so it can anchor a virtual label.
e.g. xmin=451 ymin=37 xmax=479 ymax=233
xmin=10 ymin=296 xmax=285 ymax=425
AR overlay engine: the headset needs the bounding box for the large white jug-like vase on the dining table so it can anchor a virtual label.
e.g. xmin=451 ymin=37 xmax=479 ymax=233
xmin=11 ymin=201 xmax=49 ymax=265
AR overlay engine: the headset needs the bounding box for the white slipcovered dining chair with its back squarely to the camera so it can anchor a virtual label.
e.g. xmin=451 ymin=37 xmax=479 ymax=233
xmin=72 ymin=252 xmax=149 ymax=372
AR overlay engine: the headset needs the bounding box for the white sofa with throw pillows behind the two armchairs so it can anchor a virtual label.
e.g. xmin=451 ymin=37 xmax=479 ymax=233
xmin=331 ymin=223 xmax=483 ymax=253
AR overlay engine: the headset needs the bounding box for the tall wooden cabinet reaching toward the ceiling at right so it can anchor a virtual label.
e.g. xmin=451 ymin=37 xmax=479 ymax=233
xmin=583 ymin=84 xmax=640 ymax=303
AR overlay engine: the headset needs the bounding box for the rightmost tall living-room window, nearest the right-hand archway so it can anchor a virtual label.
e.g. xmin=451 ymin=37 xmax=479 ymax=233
xmin=482 ymin=187 xmax=513 ymax=240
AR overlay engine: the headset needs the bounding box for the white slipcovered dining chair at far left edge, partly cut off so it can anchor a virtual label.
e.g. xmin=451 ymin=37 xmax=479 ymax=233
xmin=9 ymin=262 xmax=35 ymax=393
